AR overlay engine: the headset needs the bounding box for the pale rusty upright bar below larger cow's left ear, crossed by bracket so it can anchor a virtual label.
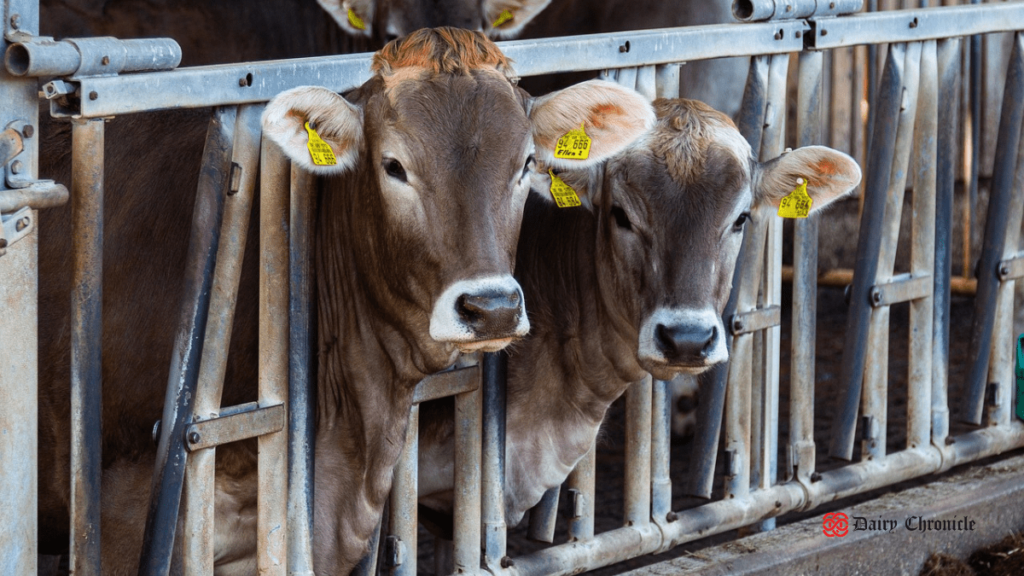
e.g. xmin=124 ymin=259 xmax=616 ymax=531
xmin=256 ymin=139 xmax=291 ymax=576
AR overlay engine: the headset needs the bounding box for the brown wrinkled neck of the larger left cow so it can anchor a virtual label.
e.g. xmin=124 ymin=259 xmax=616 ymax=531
xmin=314 ymin=166 xmax=424 ymax=573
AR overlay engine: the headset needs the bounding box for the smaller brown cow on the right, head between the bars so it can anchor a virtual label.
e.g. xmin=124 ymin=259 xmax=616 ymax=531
xmin=420 ymin=99 xmax=860 ymax=525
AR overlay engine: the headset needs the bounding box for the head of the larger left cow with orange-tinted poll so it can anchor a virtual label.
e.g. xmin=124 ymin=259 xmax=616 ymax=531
xmin=263 ymin=29 xmax=654 ymax=369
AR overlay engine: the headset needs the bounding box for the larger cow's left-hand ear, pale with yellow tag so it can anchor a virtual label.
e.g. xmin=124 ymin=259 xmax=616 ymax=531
xmin=263 ymin=86 xmax=362 ymax=174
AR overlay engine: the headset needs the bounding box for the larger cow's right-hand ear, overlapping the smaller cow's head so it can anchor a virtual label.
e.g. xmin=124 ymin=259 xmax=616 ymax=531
xmin=529 ymin=80 xmax=655 ymax=169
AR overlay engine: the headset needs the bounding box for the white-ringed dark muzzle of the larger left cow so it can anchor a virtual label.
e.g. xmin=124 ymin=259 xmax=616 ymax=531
xmin=430 ymin=276 xmax=529 ymax=352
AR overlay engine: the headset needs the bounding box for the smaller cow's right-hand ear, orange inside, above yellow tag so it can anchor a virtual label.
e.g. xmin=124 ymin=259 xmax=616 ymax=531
xmin=754 ymin=146 xmax=860 ymax=212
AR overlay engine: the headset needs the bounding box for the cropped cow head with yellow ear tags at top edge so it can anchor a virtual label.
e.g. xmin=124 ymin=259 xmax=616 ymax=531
xmin=317 ymin=0 xmax=551 ymax=41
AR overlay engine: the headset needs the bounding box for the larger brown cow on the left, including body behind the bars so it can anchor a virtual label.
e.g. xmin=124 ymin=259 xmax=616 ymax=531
xmin=40 ymin=29 xmax=654 ymax=575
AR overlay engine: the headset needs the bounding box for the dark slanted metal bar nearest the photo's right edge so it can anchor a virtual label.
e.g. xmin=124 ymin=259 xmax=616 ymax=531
xmin=963 ymin=33 xmax=1024 ymax=424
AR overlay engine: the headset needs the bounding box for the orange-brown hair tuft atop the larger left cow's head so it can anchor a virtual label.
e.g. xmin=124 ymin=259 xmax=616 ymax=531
xmin=371 ymin=28 xmax=515 ymax=81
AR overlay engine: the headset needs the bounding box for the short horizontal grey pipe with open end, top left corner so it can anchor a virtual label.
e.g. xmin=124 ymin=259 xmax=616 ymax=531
xmin=4 ymin=37 xmax=181 ymax=77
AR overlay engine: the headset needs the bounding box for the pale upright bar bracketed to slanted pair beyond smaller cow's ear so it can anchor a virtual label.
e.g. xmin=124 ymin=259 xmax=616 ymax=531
xmin=906 ymin=40 xmax=939 ymax=448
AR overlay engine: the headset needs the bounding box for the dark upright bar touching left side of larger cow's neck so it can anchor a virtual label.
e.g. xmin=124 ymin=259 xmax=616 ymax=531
xmin=288 ymin=147 xmax=315 ymax=576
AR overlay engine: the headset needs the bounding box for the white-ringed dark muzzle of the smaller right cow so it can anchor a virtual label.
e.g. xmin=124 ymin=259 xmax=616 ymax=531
xmin=638 ymin=308 xmax=729 ymax=376
